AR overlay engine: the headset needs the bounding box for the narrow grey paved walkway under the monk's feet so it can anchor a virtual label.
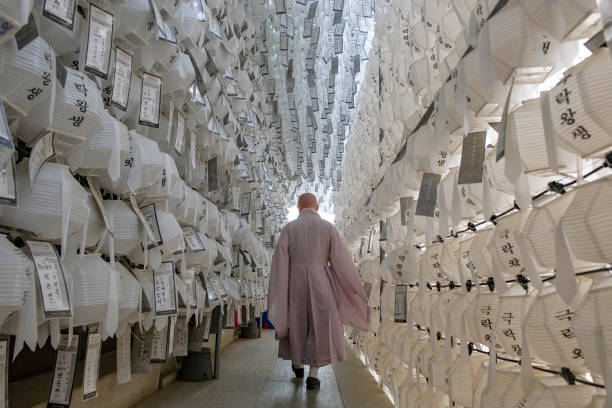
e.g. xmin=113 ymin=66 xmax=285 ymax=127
xmin=137 ymin=330 xmax=391 ymax=408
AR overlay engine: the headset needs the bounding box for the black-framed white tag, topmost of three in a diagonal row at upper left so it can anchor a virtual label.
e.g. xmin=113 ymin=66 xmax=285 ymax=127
xmin=85 ymin=4 xmax=115 ymax=79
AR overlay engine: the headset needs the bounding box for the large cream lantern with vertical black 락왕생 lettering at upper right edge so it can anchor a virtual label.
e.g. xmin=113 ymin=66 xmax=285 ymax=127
xmin=544 ymin=50 xmax=612 ymax=157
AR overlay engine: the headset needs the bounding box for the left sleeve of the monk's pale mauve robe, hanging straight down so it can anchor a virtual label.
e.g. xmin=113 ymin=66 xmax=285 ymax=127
xmin=268 ymin=228 xmax=289 ymax=339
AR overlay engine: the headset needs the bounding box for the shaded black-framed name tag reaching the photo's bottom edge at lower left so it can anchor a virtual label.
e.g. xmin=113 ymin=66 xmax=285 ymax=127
xmin=47 ymin=334 xmax=81 ymax=408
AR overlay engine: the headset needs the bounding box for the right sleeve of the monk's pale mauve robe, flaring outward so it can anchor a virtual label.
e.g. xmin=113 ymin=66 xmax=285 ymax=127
xmin=329 ymin=226 xmax=370 ymax=330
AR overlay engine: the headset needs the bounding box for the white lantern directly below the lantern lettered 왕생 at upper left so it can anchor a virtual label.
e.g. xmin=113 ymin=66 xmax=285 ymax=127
xmin=67 ymin=110 xmax=130 ymax=178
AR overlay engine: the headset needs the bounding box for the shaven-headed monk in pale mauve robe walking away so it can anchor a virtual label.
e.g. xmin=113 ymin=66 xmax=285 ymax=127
xmin=268 ymin=193 xmax=370 ymax=390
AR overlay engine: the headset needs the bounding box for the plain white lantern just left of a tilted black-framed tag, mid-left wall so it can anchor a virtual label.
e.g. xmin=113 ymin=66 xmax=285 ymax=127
xmin=102 ymin=200 xmax=144 ymax=255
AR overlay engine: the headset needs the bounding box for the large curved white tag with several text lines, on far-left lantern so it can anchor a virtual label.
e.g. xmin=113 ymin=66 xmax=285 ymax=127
xmin=26 ymin=240 xmax=71 ymax=319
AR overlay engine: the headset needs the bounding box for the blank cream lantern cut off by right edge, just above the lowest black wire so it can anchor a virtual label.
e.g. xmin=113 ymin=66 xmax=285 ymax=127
xmin=571 ymin=277 xmax=612 ymax=375
